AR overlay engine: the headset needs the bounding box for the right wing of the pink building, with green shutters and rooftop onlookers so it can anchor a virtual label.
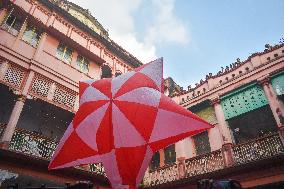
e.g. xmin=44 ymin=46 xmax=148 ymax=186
xmin=144 ymin=44 xmax=284 ymax=188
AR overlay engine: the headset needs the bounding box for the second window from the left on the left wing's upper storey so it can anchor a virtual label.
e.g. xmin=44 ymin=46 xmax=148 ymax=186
xmin=22 ymin=25 xmax=42 ymax=47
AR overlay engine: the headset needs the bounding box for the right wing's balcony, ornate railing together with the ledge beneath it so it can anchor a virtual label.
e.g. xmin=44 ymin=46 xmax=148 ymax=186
xmin=143 ymin=133 xmax=284 ymax=188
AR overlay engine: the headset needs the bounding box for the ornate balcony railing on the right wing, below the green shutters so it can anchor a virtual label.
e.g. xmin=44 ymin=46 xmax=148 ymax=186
xmin=143 ymin=133 xmax=284 ymax=187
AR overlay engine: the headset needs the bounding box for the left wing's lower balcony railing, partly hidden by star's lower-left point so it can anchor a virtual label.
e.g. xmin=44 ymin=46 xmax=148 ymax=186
xmin=0 ymin=124 xmax=105 ymax=175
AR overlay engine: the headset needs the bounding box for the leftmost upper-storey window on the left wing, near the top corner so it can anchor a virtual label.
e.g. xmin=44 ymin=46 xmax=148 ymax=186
xmin=1 ymin=9 xmax=23 ymax=36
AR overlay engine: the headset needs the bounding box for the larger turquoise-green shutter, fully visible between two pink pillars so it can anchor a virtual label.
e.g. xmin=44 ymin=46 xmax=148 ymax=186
xmin=221 ymin=84 xmax=268 ymax=119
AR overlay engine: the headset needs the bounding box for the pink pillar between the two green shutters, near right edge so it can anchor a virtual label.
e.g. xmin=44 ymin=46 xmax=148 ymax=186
xmin=259 ymin=77 xmax=284 ymax=127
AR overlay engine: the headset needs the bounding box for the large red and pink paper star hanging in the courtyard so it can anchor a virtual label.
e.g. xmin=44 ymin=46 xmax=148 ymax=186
xmin=49 ymin=59 xmax=212 ymax=189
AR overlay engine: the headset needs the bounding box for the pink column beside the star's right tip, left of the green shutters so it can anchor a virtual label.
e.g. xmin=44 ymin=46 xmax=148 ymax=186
xmin=212 ymin=97 xmax=234 ymax=167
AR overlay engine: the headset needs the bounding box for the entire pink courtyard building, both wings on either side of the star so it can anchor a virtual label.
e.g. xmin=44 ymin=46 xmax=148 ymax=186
xmin=0 ymin=0 xmax=284 ymax=188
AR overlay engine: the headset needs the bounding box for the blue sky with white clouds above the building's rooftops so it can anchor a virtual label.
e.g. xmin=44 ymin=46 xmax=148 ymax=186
xmin=69 ymin=0 xmax=284 ymax=88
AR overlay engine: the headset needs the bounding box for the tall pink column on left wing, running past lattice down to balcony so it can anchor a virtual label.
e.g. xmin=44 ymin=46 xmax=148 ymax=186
xmin=0 ymin=71 xmax=34 ymax=148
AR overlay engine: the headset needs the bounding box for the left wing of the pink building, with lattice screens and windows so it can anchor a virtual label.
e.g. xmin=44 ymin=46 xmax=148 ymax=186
xmin=0 ymin=0 xmax=142 ymax=188
